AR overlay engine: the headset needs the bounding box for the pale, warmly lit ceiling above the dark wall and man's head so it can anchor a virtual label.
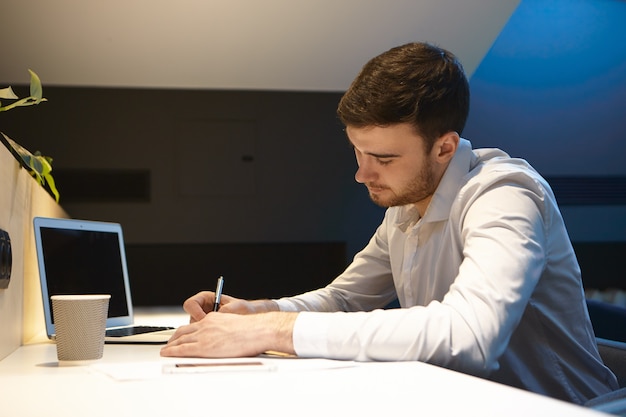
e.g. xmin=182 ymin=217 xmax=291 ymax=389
xmin=0 ymin=0 xmax=520 ymax=91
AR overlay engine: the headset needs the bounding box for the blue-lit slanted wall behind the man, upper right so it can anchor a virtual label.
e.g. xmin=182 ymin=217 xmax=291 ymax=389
xmin=464 ymin=0 xmax=626 ymax=176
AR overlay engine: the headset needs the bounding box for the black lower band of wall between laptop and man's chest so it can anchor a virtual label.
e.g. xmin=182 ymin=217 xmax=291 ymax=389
xmin=127 ymin=242 xmax=346 ymax=306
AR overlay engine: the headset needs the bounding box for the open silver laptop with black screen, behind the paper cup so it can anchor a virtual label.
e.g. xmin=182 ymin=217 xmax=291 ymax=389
xmin=33 ymin=217 xmax=174 ymax=344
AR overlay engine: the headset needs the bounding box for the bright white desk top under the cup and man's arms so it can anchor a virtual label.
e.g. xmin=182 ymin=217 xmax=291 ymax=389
xmin=0 ymin=308 xmax=603 ymax=417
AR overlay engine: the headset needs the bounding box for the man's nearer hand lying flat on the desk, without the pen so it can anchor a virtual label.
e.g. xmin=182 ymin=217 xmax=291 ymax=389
xmin=161 ymin=308 xmax=298 ymax=358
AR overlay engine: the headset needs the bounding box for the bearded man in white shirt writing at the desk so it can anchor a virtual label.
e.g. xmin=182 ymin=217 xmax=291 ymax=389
xmin=161 ymin=43 xmax=617 ymax=403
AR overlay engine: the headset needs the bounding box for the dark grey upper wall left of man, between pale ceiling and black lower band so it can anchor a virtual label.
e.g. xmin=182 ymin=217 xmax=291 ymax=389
xmin=3 ymin=87 xmax=381 ymax=253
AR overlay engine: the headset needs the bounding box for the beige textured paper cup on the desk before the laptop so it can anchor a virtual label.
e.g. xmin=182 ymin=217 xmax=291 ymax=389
xmin=50 ymin=294 xmax=111 ymax=362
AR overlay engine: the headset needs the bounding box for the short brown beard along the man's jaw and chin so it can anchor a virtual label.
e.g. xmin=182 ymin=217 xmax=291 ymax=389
xmin=368 ymin=159 xmax=437 ymax=208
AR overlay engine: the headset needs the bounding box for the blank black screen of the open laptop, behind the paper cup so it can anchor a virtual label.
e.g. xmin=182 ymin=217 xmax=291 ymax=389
xmin=41 ymin=227 xmax=128 ymax=323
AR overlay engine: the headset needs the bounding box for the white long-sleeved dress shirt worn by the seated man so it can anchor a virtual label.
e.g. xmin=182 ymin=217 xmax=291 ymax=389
xmin=276 ymin=139 xmax=617 ymax=403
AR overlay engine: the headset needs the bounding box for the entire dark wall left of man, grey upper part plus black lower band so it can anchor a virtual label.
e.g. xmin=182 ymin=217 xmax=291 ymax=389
xmin=2 ymin=85 xmax=382 ymax=304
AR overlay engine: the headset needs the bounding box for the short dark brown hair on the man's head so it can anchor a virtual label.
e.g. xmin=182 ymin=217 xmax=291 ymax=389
xmin=337 ymin=42 xmax=469 ymax=150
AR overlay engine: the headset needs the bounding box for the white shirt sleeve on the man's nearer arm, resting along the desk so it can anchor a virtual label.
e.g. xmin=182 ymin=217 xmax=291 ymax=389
xmin=286 ymin=176 xmax=545 ymax=375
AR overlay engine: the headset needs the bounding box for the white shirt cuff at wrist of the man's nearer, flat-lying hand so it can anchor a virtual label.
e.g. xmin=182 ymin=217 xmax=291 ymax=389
xmin=293 ymin=311 xmax=332 ymax=358
